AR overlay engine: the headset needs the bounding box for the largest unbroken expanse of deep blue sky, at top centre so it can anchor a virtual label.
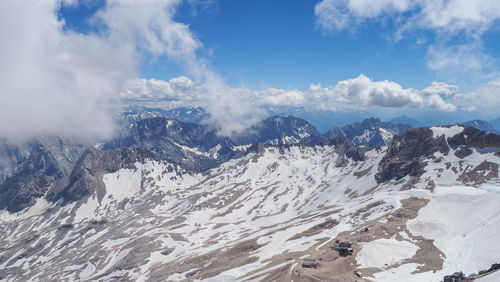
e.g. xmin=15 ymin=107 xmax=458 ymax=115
xmin=174 ymin=0 xmax=432 ymax=89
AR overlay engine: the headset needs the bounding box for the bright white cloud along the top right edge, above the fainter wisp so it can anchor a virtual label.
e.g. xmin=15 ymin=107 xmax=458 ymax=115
xmin=314 ymin=0 xmax=500 ymax=33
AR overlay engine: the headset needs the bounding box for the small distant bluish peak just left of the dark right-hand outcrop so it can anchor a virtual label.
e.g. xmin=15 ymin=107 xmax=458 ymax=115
xmin=325 ymin=118 xmax=411 ymax=147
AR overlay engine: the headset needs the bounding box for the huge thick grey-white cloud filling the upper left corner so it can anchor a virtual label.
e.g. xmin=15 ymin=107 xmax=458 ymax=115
xmin=0 ymin=0 xmax=135 ymax=138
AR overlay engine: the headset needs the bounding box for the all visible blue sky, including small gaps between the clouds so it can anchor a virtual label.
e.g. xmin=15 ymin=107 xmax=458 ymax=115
xmin=60 ymin=0 xmax=500 ymax=89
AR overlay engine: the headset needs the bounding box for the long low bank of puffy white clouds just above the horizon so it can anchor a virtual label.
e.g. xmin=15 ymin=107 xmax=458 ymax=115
xmin=121 ymin=74 xmax=459 ymax=114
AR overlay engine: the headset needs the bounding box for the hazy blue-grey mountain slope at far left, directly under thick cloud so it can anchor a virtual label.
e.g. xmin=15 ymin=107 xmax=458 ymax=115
xmin=0 ymin=136 xmax=90 ymax=212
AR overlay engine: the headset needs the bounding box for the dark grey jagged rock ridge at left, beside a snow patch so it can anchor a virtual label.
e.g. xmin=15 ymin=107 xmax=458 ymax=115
xmin=47 ymin=147 xmax=159 ymax=203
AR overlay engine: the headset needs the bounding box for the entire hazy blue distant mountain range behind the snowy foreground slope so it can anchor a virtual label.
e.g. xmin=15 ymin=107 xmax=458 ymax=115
xmin=0 ymin=107 xmax=498 ymax=214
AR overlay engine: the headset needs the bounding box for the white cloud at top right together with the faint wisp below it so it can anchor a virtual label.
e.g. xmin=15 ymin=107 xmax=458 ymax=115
xmin=314 ymin=0 xmax=500 ymax=73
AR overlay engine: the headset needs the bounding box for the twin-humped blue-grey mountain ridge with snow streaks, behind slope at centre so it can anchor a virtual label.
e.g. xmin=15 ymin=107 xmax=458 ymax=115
xmin=102 ymin=117 xmax=324 ymax=171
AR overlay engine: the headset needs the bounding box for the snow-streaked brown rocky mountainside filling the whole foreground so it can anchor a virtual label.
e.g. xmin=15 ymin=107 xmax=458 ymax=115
xmin=0 ymin=124 xmax=500 ymax=281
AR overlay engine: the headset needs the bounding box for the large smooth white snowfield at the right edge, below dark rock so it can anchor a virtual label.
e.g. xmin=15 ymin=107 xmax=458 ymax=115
xmin=407 ymin=186 xmax=500 ymax=273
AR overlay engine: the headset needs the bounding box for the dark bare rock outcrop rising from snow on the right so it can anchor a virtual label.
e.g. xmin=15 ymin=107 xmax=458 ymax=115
xmin=375 ymin=127 xmax=450 ymax=183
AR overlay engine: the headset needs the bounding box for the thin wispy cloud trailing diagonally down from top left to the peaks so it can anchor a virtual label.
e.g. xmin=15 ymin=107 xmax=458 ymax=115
xmin=96 ymin=0 xmax=261 ymax=134
